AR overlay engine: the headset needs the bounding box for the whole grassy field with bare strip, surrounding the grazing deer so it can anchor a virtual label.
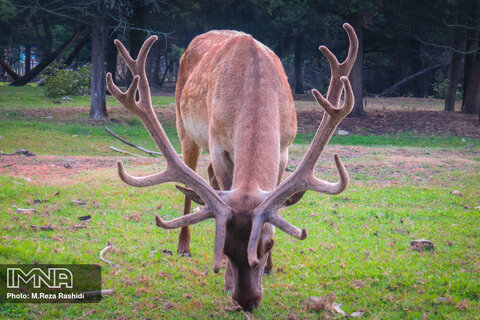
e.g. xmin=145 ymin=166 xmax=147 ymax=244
xmin=0 ymin=87 xmax=480 ymax=319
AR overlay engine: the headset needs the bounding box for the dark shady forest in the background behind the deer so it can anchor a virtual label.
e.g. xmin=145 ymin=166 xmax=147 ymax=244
xmin=0 ymin=0 xmax=480 ymax=118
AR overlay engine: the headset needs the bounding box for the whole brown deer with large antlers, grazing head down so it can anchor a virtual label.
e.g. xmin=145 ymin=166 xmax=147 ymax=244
xmin=106 ymin=23 xmax=358 ymax=311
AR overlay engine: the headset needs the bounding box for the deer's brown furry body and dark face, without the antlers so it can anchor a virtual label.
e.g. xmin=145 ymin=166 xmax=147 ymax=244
xmin=175 ymin=31 xmax=297 ymax=309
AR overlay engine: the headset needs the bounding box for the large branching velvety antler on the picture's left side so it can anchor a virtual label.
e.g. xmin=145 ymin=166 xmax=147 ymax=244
xmin=107 ymin=36 xmax=231 ymax=272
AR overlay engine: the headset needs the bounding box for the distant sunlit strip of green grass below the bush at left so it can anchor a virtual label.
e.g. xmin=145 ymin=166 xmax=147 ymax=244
xmin=0 ymin=85 xmax=175 ymax=109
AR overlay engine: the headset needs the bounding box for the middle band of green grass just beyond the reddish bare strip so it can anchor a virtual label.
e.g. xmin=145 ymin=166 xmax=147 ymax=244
xmin=0 ymin=119 xmax=480 ymax=156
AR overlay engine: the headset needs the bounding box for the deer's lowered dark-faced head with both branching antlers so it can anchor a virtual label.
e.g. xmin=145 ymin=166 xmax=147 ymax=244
xmin=107 ymin=24 xmax=358 ymax=310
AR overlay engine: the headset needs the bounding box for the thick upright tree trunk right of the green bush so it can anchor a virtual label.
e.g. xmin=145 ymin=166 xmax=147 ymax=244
xmin=90 ymin=8 xmax=108 ymax=119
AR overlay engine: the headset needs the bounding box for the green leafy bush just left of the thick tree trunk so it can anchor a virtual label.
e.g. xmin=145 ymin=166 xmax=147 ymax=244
xmin=42 ymin=64 xmax=91 ymax=97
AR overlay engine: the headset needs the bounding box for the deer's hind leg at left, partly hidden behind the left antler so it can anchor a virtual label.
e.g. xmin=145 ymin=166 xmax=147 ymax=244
xmin=177 ymin=137 xmax=201 ymax=256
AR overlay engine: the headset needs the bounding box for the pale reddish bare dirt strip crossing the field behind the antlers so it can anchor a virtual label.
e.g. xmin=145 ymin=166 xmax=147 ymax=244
xmin=0 ymin=145 xmax=479 ymax=185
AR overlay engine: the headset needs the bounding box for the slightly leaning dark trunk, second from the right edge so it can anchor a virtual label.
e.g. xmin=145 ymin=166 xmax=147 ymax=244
xmin=443 ymin=27 xmax=465 ymax=111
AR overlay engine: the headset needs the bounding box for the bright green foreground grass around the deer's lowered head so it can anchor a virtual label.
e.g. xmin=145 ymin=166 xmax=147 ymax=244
xmin=0 ymin=166 xmax=480 ymax=319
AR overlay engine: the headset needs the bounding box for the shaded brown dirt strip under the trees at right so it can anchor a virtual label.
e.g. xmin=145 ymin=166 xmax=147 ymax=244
xmin=297 ymin=110 xmax=480 ymax=139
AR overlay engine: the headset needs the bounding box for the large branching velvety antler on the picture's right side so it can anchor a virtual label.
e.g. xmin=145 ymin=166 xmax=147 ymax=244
xmin=247 ymin=23 xmax=358 ymax=267
